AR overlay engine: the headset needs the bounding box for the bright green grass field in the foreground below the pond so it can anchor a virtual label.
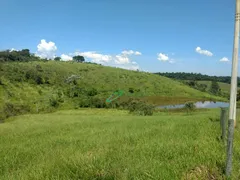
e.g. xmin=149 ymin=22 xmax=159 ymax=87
xmin=0 ymin=109 xmax=240 ymax=180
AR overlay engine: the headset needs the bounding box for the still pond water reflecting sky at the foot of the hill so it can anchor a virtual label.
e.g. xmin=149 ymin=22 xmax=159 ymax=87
xmin=158 ymin=101 xmax=229 ymax=109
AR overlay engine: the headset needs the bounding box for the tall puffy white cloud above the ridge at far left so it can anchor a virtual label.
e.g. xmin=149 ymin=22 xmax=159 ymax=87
xmin=36 ymin=39 xmax=57 ymax=59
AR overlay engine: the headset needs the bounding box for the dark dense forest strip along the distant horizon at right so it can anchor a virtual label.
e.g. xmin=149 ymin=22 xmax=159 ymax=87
xmin=154 ymin=72 xmax=240 ymax=86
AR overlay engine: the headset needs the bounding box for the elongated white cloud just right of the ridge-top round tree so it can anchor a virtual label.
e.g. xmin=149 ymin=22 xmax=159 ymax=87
xmin=75 ymin=51 xmax=112 ymax=63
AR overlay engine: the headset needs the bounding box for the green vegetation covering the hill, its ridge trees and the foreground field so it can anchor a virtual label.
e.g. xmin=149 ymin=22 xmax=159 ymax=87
xmin=0 ymin=49 xmax=236 ymax=179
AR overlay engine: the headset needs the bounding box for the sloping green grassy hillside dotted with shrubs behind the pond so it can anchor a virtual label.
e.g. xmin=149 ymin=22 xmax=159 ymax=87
xmin=0 ymin=61 xmax=225 ymax=119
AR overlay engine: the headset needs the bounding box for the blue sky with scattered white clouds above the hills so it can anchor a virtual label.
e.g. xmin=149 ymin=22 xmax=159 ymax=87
xmin=0 ymin=0 xmax=238 ymax=76
